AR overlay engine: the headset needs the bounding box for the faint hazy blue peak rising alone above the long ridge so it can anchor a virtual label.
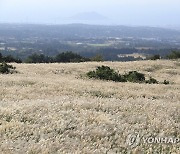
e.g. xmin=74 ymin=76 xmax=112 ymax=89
xmin=69 ymin=12 xmax=108 ymax=21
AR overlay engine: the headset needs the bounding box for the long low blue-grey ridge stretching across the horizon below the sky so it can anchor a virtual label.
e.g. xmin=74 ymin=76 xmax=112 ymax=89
xmin=0 ymin=24 xmax=180 ymax=40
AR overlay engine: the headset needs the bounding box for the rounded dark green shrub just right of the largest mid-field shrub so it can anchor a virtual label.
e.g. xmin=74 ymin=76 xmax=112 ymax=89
xmin=124 ymin=71 xmax=145 ymax=83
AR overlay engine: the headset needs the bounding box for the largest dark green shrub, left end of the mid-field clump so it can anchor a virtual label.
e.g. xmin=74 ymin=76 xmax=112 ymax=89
xmin=87 ymin=66 xmax=126 ymax=82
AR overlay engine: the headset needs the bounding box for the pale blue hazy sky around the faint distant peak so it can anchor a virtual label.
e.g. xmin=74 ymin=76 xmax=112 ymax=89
xmin=0 ymin=0 xmax=180 ymax=26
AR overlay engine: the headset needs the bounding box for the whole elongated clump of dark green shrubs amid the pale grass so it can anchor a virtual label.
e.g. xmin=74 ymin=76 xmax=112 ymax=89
xmin=86 ymin=66 xmax=169 ymax=84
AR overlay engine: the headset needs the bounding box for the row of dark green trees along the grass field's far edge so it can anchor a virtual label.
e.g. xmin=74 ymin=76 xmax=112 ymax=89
xmin=0 ymin=51 xmax=180 ymax=63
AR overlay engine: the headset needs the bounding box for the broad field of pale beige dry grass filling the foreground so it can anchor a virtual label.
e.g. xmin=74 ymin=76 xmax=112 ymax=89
xmin=0 ymin=60 xmax=180 ymax=154
